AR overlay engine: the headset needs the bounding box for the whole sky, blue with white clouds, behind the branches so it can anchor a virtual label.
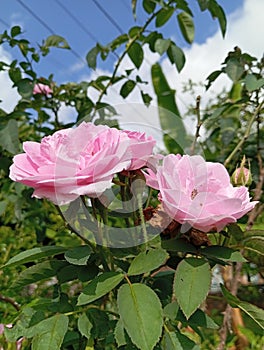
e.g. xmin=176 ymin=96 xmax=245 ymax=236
xmin=0 ymin=0 xmax=264 ymax=134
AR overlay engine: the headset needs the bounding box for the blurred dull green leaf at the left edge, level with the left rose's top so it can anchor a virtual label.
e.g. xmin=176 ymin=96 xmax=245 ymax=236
xmin=0 ymin=119 xmax=19 ymax=154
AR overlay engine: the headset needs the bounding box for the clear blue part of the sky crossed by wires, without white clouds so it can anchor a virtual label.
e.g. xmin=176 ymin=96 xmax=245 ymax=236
xmin=0 ymin=0 xmax=244 ymax=83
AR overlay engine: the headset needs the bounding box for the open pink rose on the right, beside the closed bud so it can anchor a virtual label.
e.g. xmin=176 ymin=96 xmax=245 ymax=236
xmin=146 ymin=155 xmax=257 ymax=232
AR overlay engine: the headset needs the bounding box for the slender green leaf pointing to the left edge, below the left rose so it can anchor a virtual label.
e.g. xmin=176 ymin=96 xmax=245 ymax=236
xmin=4 ymin=246 xmax=67 ymax=267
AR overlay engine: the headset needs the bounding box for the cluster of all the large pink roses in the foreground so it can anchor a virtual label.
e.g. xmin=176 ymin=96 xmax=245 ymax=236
xmin=10 ymin=122 xmax=257 ymax=232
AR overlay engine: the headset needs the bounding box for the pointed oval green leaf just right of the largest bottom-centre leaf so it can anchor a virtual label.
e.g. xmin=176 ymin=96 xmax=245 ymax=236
xmin=173 ymin=257 xmax=211 ymax=319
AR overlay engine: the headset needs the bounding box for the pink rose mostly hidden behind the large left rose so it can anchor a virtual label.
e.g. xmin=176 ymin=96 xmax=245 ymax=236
xmin=123 ymin=130 xmax=156 ymax=170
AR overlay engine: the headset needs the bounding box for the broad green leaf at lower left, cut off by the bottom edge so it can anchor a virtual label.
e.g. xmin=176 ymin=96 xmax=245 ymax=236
xmin=27 ymin=314 xmax=69 ymax=350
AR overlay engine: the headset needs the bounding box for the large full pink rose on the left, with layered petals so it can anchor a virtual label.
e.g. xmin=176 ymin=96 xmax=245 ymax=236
xmin=10 ymin=122 xmax=134 ymax=205
